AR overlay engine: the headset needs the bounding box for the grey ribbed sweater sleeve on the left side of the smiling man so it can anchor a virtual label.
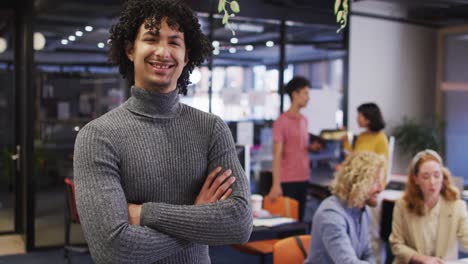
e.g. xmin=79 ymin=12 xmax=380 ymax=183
xmin=74 ymin=123 xmax=190 ymax=263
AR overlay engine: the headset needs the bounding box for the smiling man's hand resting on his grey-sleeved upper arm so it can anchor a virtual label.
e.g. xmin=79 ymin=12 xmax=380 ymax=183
xmin=195 ymin=167 xmax=236 ymax=205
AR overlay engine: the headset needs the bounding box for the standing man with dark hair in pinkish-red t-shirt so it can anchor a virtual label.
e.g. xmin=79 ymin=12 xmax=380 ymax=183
xmin=267 ymin=76 xmax=321 ymax=220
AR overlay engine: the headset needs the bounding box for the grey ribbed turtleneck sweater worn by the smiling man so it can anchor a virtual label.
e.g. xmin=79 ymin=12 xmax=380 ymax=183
xmin=74 ymin=87 xmax=252 ymax=264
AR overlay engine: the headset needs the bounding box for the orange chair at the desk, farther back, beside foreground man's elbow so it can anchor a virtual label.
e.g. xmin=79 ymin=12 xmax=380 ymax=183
xmin=233 ymin=196 xmax=299 ymax=263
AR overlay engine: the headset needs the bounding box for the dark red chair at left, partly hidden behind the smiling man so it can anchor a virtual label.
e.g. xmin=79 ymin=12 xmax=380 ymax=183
xmin=63 ymin=178 xmax=89 ymax=263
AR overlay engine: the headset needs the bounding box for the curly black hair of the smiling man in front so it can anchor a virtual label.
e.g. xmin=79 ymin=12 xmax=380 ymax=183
xmin=109 ymin=0 xmax=213 ymax=95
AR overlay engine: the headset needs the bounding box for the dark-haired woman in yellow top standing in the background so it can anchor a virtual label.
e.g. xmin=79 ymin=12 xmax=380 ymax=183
xmin=343 ymin=103 xmax=388 ymax=161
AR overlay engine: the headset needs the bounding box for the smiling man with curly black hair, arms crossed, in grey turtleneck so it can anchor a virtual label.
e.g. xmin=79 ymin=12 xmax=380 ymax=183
xmin=74 ymin=0 xmax=252 ymax=264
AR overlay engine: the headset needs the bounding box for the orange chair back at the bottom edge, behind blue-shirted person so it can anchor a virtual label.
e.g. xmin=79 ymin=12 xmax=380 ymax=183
xmin=273 ymin=235 xmax=310 ymax=264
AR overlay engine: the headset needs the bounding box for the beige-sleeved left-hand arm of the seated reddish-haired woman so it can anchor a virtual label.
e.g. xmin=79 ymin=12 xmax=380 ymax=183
xmin=389 ymin=200 xmax=417 ymax=263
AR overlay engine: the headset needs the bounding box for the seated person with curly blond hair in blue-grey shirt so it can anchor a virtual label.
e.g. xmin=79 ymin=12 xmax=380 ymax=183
xmin=305 ymin=152 xmax=385 ymax=264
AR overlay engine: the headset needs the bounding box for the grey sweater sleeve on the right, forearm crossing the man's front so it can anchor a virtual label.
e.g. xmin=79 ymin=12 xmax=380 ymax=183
xmin=141 ymin=118 xmax=252 ymax=245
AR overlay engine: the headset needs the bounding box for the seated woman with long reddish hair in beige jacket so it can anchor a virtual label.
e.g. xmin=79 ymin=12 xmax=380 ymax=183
xmin=390 ymin=150 xmax=468 ymax=264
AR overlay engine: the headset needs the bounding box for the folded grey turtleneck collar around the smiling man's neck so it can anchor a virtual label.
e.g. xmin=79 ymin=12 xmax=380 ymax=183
xmin=127 ymin=86 xmax=181 ymax=119
